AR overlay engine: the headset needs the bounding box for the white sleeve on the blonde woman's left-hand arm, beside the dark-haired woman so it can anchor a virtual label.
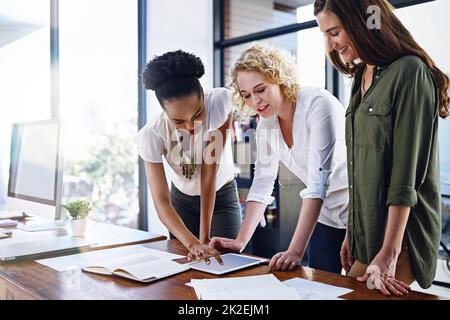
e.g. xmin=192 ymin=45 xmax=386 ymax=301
xmin=247 ymin=125 xmax=279 ymax=205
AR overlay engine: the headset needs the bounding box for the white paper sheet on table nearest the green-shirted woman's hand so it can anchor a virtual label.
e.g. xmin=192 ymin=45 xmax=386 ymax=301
xmin=283 ymin=278 xmax=353 ymax=300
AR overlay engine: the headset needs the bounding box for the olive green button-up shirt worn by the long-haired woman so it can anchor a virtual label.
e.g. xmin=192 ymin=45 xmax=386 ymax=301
xmin=345 ymin=56 xmax=441 ymax=288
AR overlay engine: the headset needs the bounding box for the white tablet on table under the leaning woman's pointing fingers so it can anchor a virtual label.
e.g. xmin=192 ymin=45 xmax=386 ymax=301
xmin=190 ymin=253 xmax=268 ymax=275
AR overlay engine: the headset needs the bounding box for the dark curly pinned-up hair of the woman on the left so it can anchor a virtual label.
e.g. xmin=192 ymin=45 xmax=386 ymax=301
xmin=142 ymin=50 xmax=205 ymax=108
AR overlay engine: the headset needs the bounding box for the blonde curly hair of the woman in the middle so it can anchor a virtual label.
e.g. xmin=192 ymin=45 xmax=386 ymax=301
xmin=230 ymin=42 xmax=300 ymax=118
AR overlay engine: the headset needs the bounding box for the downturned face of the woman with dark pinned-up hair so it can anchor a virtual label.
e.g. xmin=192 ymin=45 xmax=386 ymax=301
xmin=163 ymin=93 xmax=205 ymax=134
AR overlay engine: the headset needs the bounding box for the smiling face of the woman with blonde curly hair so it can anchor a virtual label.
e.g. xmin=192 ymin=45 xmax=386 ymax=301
xmin=236 ymin=71 xmax=283 ymax=118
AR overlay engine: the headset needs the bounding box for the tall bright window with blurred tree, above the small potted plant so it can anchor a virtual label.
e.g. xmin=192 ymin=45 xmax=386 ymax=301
xmin=59 ymin=0 xmax=139 ymax=228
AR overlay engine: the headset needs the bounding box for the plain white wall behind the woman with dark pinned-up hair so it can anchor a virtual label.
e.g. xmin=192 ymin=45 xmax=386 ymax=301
xmin=147 ymin=0 xmax=214 ymax=235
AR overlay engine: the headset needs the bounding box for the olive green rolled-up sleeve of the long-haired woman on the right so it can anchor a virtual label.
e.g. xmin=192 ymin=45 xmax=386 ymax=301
xmin=386 ymin=65 xmax=438 ymax=207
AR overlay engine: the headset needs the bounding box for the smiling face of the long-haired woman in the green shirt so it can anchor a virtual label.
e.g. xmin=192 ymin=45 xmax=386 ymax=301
xmin=316 ymin=10 xmax=358 ymax=63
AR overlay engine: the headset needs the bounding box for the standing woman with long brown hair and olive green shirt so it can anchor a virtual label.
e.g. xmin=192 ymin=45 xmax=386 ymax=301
xmin=314 ymin=0 xmax=450 ymax=295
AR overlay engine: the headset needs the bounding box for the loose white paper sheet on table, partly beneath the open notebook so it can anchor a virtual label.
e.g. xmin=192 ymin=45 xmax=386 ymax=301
xmin=36 ymin=244 xmax=184 ymax=271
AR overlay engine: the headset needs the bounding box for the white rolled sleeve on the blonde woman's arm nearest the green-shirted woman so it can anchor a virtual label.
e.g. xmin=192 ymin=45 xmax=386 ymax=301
xmin=300 ymin=97 xmax=337 ymax=200
